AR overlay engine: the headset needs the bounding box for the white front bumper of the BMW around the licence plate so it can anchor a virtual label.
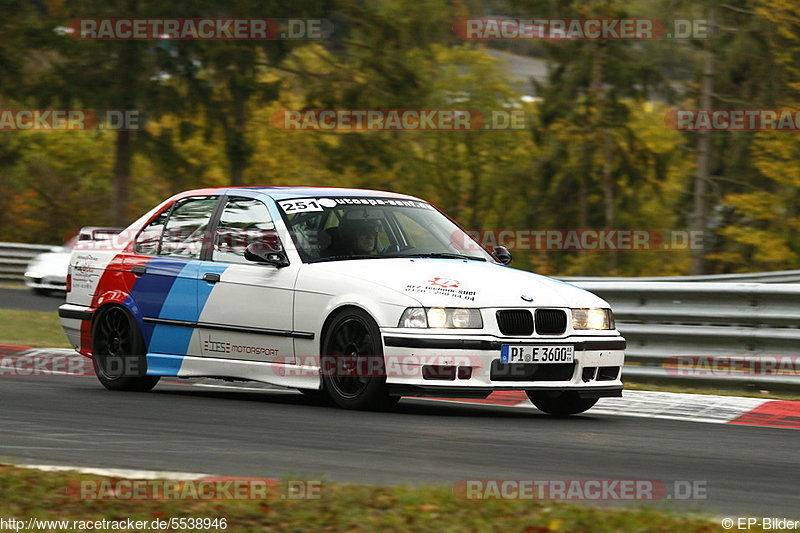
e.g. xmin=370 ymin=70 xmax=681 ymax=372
xmin=382 ymin=328 xmax=626 ymax=392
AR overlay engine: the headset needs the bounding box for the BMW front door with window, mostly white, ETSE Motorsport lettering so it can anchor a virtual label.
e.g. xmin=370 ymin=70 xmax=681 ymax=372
xmin=199 ymin=196 xmax=301 ymax=363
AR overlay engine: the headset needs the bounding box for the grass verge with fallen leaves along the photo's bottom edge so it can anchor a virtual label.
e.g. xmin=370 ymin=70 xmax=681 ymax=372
xmin=0 ymin=466 xmax=752 ymax=533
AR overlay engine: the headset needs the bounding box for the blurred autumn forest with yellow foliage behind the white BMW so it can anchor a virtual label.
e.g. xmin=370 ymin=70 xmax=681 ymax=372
xmin=0 ymin=0 xmax=800 ymax=275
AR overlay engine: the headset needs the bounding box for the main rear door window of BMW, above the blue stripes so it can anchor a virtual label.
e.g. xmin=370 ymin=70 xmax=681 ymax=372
xmin=160 ymin=196 xmax=217 ymax=259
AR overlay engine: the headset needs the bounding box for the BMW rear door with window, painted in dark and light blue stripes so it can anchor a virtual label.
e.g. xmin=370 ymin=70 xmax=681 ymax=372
xmin=130 ymin=196 xmax=219 ymax=355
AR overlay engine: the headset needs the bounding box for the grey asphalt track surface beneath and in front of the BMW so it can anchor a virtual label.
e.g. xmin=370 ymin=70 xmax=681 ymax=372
xmin=0 ymin=375 xmax=800 ymax=518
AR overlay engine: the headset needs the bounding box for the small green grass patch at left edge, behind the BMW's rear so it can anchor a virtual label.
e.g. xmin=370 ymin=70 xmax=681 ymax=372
xmin=0 ymin=309 xmax=70 ymax=348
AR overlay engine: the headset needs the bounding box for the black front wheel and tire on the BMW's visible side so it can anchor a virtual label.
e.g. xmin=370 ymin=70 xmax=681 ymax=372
xmin=320 ymin=308 xmax=400 ymax=409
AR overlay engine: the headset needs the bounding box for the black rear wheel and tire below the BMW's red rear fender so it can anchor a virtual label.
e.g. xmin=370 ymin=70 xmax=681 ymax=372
xmin=92 ymin=305 xmax=160 ymax=392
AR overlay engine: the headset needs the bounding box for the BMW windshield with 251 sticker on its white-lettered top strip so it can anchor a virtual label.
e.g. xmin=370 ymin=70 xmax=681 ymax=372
xmin=278 ymin=197 xmax=493 ymax=263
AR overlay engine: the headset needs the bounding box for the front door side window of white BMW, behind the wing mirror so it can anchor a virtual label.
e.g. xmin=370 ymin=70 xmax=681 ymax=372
xmin=211 ymin=198 xmax=280 ymax=263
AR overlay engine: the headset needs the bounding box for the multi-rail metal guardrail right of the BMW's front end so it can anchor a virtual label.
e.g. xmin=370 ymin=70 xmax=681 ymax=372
xmin=574 ymin=281 xmax=800 ymax=390
